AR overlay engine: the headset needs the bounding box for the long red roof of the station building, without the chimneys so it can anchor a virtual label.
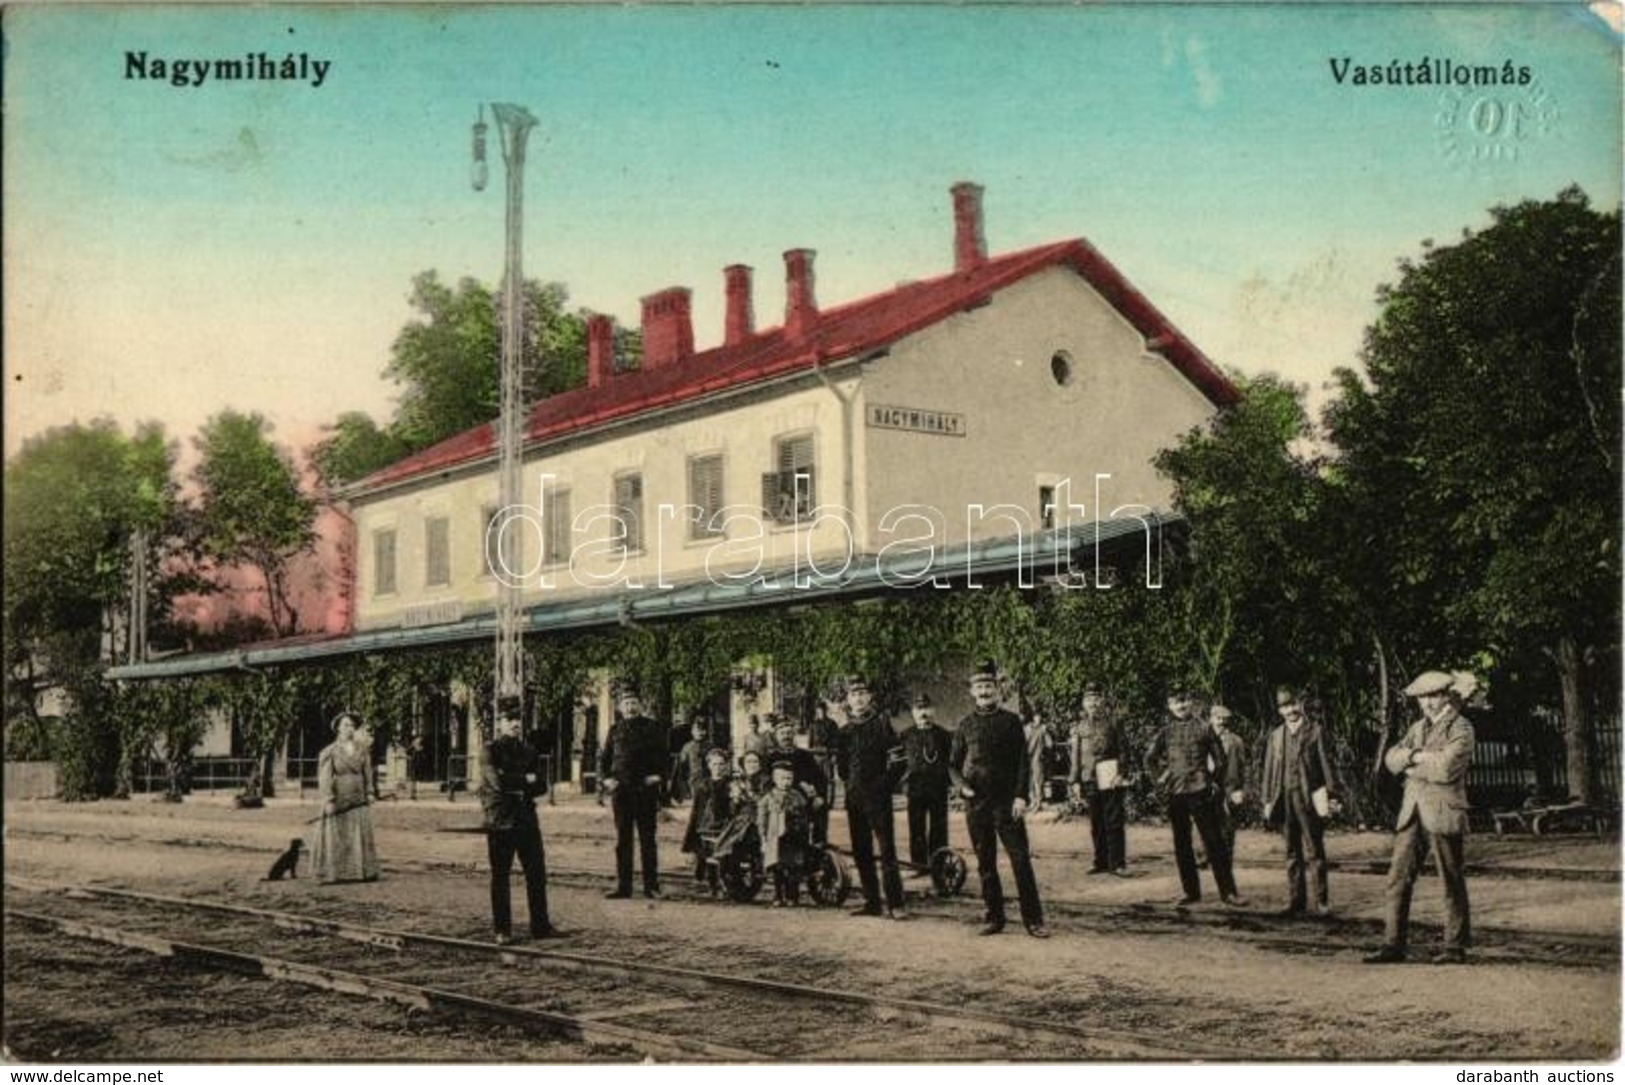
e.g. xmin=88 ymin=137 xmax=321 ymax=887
xmin=356 ymin=239 xmax=1237 ymax=491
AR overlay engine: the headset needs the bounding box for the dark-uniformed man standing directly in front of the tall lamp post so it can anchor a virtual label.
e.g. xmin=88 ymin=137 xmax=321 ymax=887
xmin=479 ymin=697 xmax=559 ymax=945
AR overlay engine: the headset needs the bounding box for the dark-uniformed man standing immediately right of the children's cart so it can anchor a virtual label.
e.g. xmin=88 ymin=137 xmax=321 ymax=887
xmin=837 ymin=674 xmax=908 ymax=919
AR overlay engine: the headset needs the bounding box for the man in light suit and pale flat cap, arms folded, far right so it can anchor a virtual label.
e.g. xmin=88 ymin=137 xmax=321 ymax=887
xmin=1365 ymin=671 xmax=1472 ymax=965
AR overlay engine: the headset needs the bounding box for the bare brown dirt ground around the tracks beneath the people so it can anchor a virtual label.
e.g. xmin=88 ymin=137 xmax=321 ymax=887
xmin=5 ymin=798 xmax=1620 ymax=1062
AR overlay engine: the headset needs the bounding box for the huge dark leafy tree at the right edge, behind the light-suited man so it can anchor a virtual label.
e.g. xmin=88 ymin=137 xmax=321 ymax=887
xmin=1326 ymin=188 xmax=1622 ymax=801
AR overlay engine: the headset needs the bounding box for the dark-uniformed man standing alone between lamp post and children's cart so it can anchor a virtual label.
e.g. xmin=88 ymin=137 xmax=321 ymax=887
xmin=598 ymin=681 xmax=666 ymax=900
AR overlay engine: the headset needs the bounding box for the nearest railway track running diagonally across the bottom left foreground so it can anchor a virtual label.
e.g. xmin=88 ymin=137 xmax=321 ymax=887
xmin=7 ymin=877 xmax=1258 ymax=1062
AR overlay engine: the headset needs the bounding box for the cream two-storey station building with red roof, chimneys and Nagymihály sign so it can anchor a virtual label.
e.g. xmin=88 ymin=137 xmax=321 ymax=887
xmin=115 ymin=184 xmax=1235 ymax=795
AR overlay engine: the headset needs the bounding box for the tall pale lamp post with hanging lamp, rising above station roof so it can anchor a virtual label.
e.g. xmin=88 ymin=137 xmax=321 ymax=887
xmin=473 ymin=102 xmax=536 ymax=702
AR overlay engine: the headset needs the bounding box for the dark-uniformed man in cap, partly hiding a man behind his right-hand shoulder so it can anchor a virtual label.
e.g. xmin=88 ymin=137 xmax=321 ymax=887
xmin=1146 ymin=690 xmax=1246 ymax=906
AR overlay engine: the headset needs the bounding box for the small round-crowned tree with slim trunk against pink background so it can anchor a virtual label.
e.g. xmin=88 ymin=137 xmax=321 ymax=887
xmin=192 ymin=411 xmax=315 ymax=637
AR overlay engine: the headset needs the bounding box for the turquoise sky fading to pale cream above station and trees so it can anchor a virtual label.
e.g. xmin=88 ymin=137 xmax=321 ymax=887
xmin=3 ymin=3 xmax=1620 ymax=455
